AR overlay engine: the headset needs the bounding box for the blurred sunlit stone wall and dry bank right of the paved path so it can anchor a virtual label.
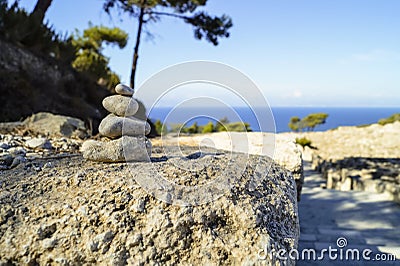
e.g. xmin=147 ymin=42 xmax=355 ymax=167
xmin=298 ymin=122 xmax=400 ymax=203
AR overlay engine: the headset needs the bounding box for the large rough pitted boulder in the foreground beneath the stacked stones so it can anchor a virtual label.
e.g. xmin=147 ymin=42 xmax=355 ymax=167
xmin=0 ymin=144 xmax=299 ymax=265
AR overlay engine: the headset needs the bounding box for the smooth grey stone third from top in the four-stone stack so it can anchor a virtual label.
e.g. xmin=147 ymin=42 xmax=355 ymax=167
xmin=99 ymin=114 xmax=151 ymax=138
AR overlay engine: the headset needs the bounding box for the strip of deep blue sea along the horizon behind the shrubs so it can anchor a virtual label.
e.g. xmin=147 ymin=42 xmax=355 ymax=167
xmin=149 ymin=107 xmax=400 ymax=133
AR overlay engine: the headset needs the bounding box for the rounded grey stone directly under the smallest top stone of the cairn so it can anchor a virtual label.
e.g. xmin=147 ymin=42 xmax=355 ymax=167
xmin=103 ymin=95 xmax=139 ymax=116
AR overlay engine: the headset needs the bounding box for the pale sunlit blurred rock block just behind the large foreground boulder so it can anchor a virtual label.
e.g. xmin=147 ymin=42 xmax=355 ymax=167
xmin=155 ymin=132 xmax=304 ymax=200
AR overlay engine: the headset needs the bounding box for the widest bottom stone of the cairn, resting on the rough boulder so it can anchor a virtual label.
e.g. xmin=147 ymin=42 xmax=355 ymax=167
xmin=81 ymin=136 xmax=152 ymax=162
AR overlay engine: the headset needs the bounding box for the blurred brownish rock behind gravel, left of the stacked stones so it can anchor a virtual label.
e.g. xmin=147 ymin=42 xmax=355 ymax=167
xmin=23 ymin=112 xmax=88 ymax=138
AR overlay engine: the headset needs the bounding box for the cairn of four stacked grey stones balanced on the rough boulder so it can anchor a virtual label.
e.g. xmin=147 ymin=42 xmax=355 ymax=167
xmin=81 ymin=84 xmax=151 ymax=162
